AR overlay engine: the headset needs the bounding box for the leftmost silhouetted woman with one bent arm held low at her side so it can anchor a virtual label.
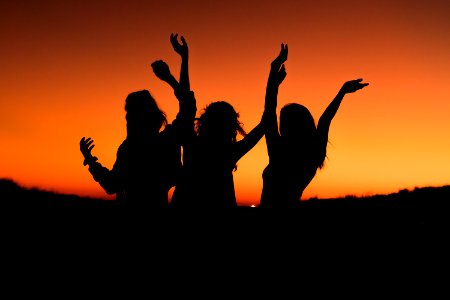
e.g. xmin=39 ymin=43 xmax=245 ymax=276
xmin=80 ymin=90 xmax=181 ymax=209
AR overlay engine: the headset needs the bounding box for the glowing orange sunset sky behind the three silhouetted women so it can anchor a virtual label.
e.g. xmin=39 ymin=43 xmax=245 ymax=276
xmin=0 ymin=0 xmax=450 ymax=205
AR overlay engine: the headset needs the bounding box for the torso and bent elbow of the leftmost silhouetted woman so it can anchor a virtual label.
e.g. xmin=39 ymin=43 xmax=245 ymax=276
xmin=90 ymin=125 xmax=181 ymax=209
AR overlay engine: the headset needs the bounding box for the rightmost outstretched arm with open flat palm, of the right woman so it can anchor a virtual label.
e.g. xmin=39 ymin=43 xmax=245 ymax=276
xmin=317 ymin=78 xmax=369 ymax=149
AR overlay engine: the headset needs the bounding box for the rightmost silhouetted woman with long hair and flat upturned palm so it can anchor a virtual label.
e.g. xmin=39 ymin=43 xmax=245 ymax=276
xmin=260 ymin=45 xmax=368 ymax=208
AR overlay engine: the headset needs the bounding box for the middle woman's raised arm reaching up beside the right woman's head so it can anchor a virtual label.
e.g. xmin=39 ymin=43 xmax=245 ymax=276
xmin=235 ymin=44 xmax=288 ymax=161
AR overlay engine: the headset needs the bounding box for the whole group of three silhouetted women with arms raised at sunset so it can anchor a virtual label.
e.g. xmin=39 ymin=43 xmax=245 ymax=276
xmin=80 ymin=34 xmax=368 ymax=209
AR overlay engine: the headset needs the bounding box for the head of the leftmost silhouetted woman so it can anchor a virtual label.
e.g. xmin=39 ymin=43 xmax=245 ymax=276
xmin=125 ymin=90 xmax=167 ymax=135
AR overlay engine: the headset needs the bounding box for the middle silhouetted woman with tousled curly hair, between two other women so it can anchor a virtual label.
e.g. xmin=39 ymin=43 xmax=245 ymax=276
xmin=155 ymin=34 xmax=284 ymax=208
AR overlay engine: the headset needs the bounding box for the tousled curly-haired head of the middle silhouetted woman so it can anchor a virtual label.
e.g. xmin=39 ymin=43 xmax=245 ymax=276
xmin=196 ymin=101 xmax=246 ymax=142
